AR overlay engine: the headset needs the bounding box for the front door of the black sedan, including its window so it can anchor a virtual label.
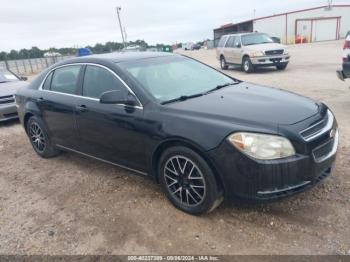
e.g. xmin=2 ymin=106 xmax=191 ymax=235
xmin=76 ymin=65 xmax=146 ymax=170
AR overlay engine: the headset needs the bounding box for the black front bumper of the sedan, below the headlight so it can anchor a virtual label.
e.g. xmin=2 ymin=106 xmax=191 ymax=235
xmin=208 ymin=118 xmax=338 ymax=201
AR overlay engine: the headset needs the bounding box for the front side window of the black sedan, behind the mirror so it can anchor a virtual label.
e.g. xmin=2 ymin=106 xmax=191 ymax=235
xmin=83 ymin=65 xmax=125 ymax=98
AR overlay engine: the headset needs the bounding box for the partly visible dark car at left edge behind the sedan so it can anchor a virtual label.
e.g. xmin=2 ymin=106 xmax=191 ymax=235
xmin=0 ymin=68 xmax=27 ymax=122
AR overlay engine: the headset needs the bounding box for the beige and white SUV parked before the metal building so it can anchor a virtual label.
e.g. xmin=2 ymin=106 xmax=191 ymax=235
xmin=216 ymin=33 xmax=290 ymax=73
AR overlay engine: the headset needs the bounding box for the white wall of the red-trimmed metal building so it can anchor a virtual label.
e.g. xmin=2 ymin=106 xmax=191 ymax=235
xmin=253 ymin=6 xmax=350 ymax=43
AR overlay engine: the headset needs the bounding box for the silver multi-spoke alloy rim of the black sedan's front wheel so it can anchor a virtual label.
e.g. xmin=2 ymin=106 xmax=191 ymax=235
xmin=163 ymin=155 xmax=206 ymax=207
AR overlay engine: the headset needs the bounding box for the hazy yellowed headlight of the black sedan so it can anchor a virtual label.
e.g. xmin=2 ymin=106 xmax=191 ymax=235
xmin=228 ymin=132 xmax=295 ymax=160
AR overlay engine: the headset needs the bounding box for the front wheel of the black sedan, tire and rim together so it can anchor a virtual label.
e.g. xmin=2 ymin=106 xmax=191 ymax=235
xmin=158 ymin=146 xmax=223 ymax=215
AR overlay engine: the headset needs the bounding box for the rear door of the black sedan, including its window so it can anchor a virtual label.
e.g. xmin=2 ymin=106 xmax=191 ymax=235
xmin=37 ymin=65 xmax=83 ymax=148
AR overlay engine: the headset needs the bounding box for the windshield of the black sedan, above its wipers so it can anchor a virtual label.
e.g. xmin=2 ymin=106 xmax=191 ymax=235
xmin=120 ymin=56 xmax=235 ymax=103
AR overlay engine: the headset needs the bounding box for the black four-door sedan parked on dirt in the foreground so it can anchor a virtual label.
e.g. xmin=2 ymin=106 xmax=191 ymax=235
xmin=16 ymin=52 xmax=338 ymax=214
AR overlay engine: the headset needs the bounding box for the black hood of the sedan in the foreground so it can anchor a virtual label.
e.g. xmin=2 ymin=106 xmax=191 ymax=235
xmin=166 ymin=82 xmax=319 ymax=125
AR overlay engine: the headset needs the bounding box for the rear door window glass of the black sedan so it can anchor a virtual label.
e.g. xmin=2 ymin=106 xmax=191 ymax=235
xmin=51 ymin=65 xmax=81 ymax=94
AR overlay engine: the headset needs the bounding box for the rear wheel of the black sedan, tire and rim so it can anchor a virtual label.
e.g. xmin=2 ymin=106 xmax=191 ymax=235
xmin=26 ymin=116 xmax=60 ymax=158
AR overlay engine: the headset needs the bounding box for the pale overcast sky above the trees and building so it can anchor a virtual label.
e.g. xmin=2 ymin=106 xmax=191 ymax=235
xmin=0 ymin=0 xmax=350 ymax=52
